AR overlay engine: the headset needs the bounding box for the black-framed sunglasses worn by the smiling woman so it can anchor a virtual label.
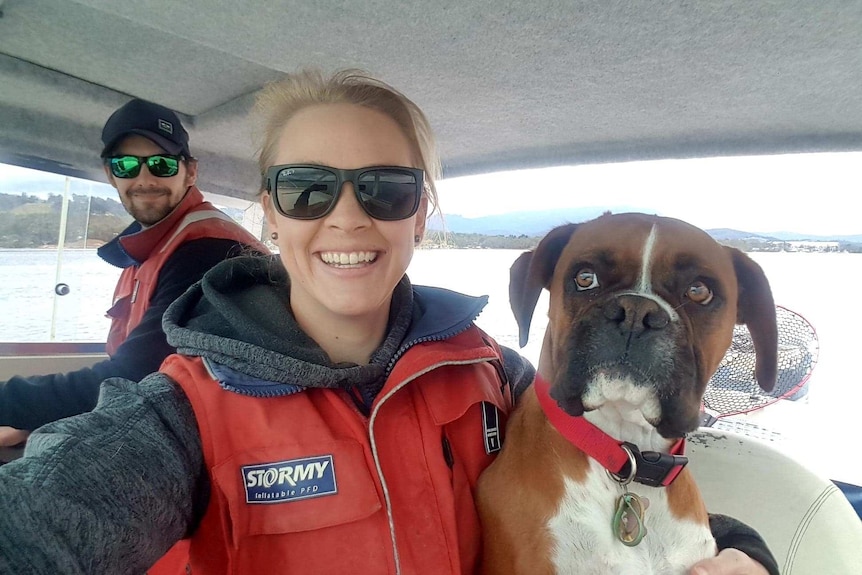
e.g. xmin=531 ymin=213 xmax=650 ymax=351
xmin=266 ymin=165 xmax=425 ymax=221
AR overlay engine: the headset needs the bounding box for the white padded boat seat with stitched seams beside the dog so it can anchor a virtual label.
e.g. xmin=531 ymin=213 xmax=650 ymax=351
xmin=687 ymin=428 xmax=862 ymax=575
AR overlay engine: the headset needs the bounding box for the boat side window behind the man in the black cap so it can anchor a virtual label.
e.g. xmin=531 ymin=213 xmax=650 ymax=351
xmin=0 ymin=160 xmax=264 ymax=343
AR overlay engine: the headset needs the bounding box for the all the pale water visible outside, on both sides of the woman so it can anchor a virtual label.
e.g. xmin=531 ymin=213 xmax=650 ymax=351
xmin=0 ymin=250 xmax=862 ymax=485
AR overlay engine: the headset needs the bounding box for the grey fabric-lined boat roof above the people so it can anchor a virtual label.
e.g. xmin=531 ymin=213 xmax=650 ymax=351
xmin=0 ymin=0 xmax=862 ymax=197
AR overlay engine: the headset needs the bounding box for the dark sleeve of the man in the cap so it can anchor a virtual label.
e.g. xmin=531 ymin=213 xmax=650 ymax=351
xmin=0 ymin=238 xmax=253 ymax=430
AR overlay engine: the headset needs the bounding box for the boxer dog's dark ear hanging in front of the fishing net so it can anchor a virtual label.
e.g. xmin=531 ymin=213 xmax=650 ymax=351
xmin=724 ymin=246 xmax=778 ymax=391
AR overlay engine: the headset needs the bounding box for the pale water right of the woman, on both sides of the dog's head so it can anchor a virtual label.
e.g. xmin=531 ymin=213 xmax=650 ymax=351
xmin=408 ymin=250 xmax=862 ymax=485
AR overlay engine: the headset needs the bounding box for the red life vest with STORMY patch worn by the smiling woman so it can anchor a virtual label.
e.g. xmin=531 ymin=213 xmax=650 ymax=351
xmin=161 ymin=327 xmax=512 ymax=575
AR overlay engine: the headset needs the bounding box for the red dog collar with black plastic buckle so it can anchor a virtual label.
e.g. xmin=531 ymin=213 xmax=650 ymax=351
xmin=533 ymin=375 xmax=688 ymax=487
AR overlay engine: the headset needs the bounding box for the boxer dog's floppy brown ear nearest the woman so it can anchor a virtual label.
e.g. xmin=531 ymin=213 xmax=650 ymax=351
xmin=509 ymin=224 xmax=578 ymax=347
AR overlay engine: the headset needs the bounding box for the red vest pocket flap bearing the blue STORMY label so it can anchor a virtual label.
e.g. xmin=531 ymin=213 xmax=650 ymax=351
xmin=213 ymin=440 xmax=382 ymax=546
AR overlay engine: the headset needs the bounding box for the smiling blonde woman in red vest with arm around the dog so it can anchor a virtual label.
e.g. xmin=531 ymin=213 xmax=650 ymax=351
xmin=0 ymin=72 xmax=771 ymax=575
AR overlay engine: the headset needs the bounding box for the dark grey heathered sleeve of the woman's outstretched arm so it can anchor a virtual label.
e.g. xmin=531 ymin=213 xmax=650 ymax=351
xmin=0 ymin=374 xmax=209 ymax=575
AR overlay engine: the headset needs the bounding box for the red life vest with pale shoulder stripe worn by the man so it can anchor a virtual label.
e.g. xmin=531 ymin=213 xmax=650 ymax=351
xmin=105 ymin=186 xmax=269 ymax=355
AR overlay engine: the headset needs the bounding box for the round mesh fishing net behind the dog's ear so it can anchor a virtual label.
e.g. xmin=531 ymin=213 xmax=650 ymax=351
xmin=703 ymin=306 xmax=820 ymax=418
